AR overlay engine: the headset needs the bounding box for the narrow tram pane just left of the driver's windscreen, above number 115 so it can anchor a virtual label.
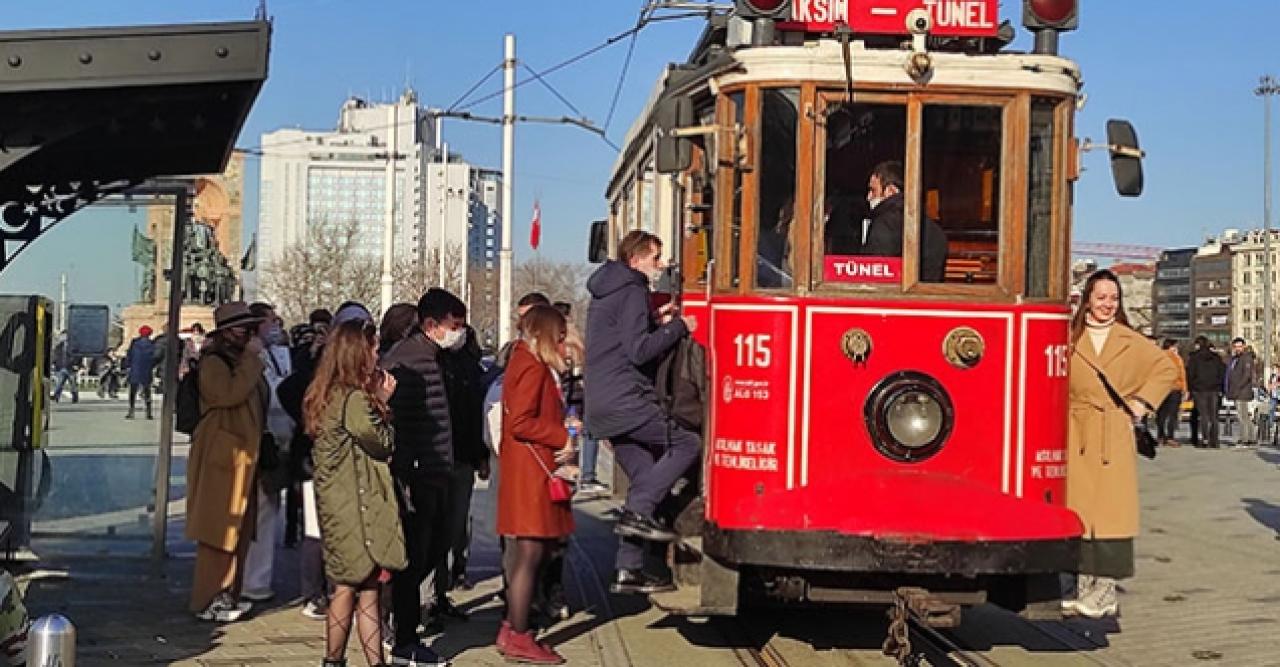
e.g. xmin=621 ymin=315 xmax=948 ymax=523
xmin=755 ymin=88 xmax=800 ymax=289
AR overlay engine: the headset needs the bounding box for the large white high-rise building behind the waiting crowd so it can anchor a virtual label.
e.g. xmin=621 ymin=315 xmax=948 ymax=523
xmin=257 ymin=90 xmax=500 ymax=320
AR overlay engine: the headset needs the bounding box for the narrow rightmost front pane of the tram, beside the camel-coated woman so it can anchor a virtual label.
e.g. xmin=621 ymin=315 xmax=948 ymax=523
xmin=1027 ymin=97 xmax=1059 ymax=297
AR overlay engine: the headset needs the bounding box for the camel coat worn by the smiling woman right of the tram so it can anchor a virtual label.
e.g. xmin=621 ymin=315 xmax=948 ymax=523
xmin=1066 ymin=324 xmax=1178 ymax=539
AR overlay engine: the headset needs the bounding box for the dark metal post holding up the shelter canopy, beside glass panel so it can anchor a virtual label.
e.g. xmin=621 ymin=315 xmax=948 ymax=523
xmin=151 ymin=186 xmax=191 ymax=563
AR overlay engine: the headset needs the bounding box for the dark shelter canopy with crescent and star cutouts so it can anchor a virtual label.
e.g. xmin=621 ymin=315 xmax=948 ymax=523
xmin=0 ymin=20 xmax=270 ymax=271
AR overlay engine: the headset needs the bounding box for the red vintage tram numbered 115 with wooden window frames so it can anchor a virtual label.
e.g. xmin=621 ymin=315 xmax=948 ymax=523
xmin=591 ymin=0 xmax=1142 ymax=622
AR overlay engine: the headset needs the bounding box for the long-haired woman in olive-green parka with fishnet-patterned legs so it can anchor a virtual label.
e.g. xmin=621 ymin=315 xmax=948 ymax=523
xmin=302 ymin=320 xmax=406 ymax=667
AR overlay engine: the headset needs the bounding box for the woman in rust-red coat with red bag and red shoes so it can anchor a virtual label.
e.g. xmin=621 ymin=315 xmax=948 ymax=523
xmin=497 ymin=306 xmax=581 ymax=664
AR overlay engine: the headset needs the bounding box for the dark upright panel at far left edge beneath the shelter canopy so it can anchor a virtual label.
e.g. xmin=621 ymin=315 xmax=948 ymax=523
xmin=0 ymin=296 xmax=52 ymax=558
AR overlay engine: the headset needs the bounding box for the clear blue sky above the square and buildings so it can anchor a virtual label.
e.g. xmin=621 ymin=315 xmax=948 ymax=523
xmin=0 ymin=0 xmax=1280 ymax=312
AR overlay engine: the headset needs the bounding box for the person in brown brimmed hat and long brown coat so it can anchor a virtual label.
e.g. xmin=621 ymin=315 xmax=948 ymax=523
xmin=187 ymin=301 xmax=269 ymax=622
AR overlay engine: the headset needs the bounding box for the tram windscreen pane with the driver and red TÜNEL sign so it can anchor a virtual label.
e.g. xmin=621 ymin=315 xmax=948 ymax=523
xmin=818 ymin=102 xmax=906 ymax=284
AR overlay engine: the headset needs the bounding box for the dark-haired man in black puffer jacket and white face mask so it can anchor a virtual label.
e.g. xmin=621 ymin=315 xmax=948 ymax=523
xmin=381 ymin=288 xmax=467 ymax=664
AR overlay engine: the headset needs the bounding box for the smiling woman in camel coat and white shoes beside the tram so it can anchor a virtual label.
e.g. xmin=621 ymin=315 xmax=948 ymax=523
xmin=1064 ymin=270 xmax=1178 ymax=617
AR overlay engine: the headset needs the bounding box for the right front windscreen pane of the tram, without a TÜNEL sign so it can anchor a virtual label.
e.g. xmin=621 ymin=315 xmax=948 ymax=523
xmin=920 ymin=105 xmax=1004 ymax=284
